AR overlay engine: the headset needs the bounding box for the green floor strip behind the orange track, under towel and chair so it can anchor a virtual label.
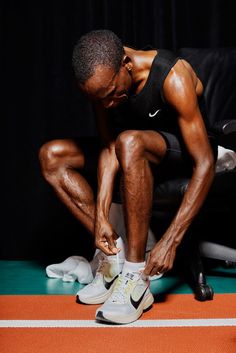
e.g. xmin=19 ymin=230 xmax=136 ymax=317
xmin=0 ymin=260 xmax=236 ymax=295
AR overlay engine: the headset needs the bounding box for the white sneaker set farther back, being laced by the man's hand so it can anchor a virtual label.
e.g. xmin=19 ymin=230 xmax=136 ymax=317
xmin=76 ymin=253 xmax=124 ymax=304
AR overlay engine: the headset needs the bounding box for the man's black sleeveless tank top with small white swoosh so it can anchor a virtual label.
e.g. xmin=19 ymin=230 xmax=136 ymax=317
xmin=109 ymin=49 xmax=208 ymax=135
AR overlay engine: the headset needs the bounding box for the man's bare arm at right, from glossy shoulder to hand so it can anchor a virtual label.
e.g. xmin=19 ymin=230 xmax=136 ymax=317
xmin=145 ymin=63 xmax=214 ymax=274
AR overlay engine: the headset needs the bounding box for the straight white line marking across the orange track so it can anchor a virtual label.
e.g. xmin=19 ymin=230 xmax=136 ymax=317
xmin=0 ymin=318 xmax=236 ymax=328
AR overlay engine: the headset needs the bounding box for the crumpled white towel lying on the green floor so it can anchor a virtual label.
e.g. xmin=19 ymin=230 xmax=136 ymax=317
xmin=46 ymin=256 xmax=93 ymax=284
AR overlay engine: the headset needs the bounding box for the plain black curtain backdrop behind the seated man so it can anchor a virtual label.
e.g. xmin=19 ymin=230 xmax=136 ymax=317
xmin=0 ymin=0 xmax=236 ymax=261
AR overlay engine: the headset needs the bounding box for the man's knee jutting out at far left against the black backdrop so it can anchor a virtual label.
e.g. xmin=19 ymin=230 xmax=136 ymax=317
xmin=39 ymin=140 xmax=83 ymax=182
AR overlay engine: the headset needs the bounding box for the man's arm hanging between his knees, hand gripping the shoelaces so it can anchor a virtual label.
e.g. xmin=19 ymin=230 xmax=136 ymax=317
xmin=95 ymin=106 xmax=119 ymax=255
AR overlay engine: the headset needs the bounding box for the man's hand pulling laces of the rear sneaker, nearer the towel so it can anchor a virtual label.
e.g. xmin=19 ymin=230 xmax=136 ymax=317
xmin=95 ymin=216 xmax=120 ymax=255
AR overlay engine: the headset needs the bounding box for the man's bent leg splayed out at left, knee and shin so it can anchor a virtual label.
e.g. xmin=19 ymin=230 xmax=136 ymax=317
xmin=39 ymin=139 xmax=96 ymax=234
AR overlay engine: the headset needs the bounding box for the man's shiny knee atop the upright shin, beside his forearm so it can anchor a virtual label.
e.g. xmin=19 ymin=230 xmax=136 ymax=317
xmin=116 ymin=130 xmax=144 ymax=166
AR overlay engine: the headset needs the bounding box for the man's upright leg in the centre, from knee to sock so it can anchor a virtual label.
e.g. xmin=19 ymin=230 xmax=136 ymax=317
xmin=116 ymin=130 xmax=167 ymax=262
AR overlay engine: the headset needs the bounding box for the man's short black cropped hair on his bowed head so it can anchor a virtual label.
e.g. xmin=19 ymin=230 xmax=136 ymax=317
xmin=72 ymin=29 xmax=124 ymax=84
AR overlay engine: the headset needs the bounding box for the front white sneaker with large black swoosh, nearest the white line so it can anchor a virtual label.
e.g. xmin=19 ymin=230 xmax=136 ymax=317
xmin=96 ymin=272 xmax=154 ymax=324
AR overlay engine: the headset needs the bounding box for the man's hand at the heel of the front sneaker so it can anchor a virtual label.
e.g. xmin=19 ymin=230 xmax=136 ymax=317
xmin=144 ymin=239 xmax=176 ymax=276
